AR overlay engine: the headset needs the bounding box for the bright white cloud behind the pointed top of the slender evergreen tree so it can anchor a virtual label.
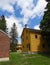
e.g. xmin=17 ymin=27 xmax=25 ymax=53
xmin=6 ymin=16 xmax=23 ymax=37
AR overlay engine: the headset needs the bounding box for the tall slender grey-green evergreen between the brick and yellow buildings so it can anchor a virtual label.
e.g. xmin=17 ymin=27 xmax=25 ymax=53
xmin=10 ymin=23 xmax=18 ymax=51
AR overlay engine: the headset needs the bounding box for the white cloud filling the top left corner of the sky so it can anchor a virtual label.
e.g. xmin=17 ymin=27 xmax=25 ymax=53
xmin=0 ymin=0 xmax=16 ymax=13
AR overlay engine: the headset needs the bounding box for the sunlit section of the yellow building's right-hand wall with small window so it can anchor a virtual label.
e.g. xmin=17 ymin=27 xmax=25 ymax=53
xmin=30 ymin=33 xmax=41 ymax=52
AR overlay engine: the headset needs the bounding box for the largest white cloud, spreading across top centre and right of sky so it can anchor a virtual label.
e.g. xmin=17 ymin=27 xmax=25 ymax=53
xmin=14 ymin=0 xmax=47 ymax=24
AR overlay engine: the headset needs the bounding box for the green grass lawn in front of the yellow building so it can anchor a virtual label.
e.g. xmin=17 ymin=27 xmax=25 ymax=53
xmin=0 ymin=52 xmax=50 ymax=65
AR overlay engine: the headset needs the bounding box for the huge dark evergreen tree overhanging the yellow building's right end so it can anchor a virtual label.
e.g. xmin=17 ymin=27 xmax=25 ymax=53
xmin=40 ymin=0 xmax=50 ymax=47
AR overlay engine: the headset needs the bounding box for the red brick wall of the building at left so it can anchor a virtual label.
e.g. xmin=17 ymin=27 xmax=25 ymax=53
xmin=0 ymin=32 xmax=10 ymax=58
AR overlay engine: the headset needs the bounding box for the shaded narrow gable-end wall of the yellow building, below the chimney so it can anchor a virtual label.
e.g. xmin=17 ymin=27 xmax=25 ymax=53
xmin=22 ymin=29 xmax=30 ymax=52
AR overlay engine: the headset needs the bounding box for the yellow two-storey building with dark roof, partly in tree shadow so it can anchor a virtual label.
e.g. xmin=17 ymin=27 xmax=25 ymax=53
xmin=21 ymin=28 xmax=48 ymax=53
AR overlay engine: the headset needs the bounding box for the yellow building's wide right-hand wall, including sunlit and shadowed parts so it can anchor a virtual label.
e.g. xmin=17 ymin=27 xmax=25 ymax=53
xmin=30 ymin=33 xmax=49 ymax=52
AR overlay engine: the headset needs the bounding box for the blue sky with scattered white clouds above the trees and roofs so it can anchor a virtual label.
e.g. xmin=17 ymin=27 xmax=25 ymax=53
xmin=0 ymin=0 xmax=47 ymax=43
